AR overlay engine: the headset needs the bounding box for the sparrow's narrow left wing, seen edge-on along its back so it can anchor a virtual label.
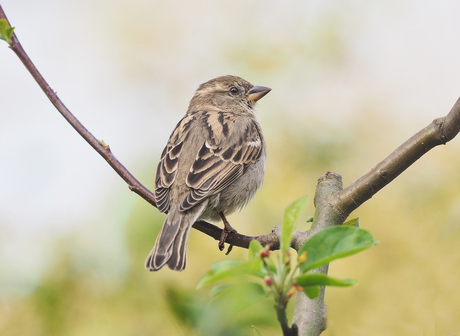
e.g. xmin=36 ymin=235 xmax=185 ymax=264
xmin=155 ymin=115 xmax=195 ymax=212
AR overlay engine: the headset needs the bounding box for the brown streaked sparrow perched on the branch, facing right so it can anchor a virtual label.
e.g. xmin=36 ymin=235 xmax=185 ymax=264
xmin=145 ymin=75 xmax=271 ymax=271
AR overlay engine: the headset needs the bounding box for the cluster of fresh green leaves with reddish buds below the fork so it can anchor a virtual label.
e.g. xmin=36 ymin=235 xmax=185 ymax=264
xmin=197 ymin=197 xmax=377 ymax=326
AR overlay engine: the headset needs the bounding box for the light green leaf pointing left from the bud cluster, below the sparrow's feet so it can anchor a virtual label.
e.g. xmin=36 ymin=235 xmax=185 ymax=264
xmin=196 ymin=259 xmax=264 ymax=288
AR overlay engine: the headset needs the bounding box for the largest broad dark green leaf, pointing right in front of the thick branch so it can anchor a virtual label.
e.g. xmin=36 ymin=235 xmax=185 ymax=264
xmin=298 ymin=226 xmax=378 ymax=273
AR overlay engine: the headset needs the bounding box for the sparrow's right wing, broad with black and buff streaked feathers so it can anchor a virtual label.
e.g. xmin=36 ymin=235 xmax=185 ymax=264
xmin=181 ymin=112 xmax=263 ymax=211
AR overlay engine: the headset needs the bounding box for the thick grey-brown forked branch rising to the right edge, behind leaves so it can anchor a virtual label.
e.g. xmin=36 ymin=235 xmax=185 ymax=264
xmin=293 ymin=98 xmax=460 ymax=335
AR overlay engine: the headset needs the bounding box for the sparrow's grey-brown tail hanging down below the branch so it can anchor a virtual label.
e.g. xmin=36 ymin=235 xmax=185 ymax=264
xmin=145 ymin=206 xmax=201 ymax=271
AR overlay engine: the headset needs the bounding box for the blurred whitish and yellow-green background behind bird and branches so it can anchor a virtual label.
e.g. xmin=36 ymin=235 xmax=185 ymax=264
xmin=0 ymin=0 xmax=460 ymax=336
